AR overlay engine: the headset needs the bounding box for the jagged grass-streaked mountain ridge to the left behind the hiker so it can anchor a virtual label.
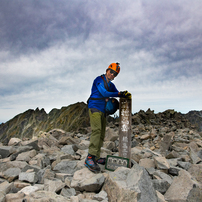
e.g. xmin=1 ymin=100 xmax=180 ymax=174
xmin=0 ymin=102 xmax=89 ymax=143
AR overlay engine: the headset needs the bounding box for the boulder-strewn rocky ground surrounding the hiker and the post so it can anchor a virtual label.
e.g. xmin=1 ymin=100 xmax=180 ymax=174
xmin=0 ymin=110 xmax=202 ymax=202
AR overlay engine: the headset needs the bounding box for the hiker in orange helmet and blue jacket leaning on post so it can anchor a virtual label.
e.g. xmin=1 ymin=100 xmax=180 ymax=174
xmin=84 ymin=63 xmax=131 ymax=173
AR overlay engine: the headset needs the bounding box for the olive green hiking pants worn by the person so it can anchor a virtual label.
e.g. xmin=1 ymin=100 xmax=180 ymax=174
xmin=88 ymin=109 xmax=106 ymax=159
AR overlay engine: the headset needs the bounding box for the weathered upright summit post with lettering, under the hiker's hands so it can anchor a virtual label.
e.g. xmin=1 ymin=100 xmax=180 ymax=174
xmin=119 ymin=98 xmax=132 ymax=167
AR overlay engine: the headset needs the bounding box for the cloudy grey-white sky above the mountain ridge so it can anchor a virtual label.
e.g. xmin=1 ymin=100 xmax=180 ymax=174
xmin=0 ymin=0 xmax=202 ymax=123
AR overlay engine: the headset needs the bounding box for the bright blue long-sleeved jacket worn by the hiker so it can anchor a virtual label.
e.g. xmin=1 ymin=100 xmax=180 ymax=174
xmin=88 ymin=75 xmax=119 ymax=113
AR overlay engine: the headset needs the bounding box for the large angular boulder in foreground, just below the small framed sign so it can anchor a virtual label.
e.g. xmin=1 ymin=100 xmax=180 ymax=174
xmin=103 ymin=164 xmax=157 ymax=202
